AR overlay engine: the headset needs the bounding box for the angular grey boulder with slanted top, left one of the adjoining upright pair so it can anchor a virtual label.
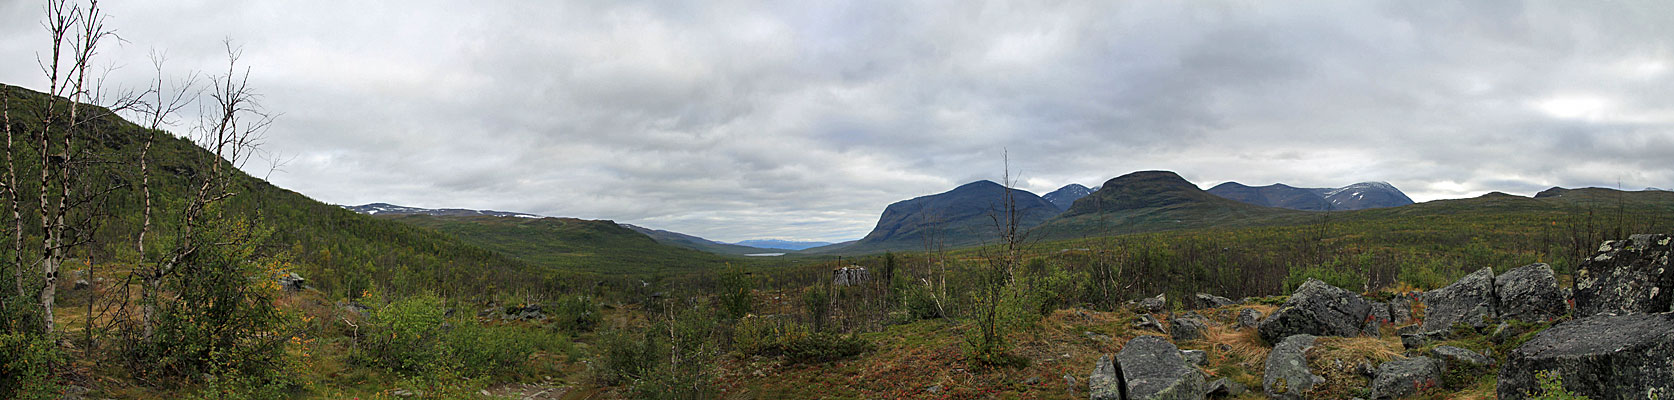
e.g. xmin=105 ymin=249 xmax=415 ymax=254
xmin=1423 ymin=268 xmax=1495 ymax=333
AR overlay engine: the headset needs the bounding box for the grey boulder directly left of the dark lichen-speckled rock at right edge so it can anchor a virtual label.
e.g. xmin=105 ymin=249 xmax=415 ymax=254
xmin=1493 ymin=263 xmax=1569 ymax=321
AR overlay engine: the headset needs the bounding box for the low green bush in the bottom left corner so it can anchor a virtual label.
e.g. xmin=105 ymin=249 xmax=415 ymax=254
xmin=0 ymin=333 xmax=64 ymax=398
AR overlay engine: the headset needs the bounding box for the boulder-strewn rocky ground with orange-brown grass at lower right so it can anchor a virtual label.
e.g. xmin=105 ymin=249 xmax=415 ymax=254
xmin=1086 ymin=234 xmax=1674 ymax=400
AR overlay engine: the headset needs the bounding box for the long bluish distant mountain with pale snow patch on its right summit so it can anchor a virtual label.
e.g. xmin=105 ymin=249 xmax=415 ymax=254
xmin=1209 ymin=182 xmax=1413 ymax=211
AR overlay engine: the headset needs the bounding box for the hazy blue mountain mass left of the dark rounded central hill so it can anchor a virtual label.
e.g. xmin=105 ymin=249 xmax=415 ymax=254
xmin=810 ymin=181 xmax=1060 ymax=253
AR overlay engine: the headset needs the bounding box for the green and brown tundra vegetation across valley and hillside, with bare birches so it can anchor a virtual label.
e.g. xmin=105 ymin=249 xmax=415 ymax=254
xmin=0 ymin=0 xmax=1674 ymax=398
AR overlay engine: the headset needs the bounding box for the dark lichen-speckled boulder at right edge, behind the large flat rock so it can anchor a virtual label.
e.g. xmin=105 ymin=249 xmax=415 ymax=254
xmin=1575 ymin=234 xmax=1674 ymax=316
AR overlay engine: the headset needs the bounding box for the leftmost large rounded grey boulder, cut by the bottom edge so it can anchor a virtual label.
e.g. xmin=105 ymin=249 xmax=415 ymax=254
xmin=1117 ymin=335 xmax=1205 ymax=400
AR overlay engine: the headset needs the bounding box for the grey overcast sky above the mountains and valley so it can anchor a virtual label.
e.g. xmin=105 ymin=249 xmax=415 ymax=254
xmin=0 ymin=0 xmax=1674 ymax=241
